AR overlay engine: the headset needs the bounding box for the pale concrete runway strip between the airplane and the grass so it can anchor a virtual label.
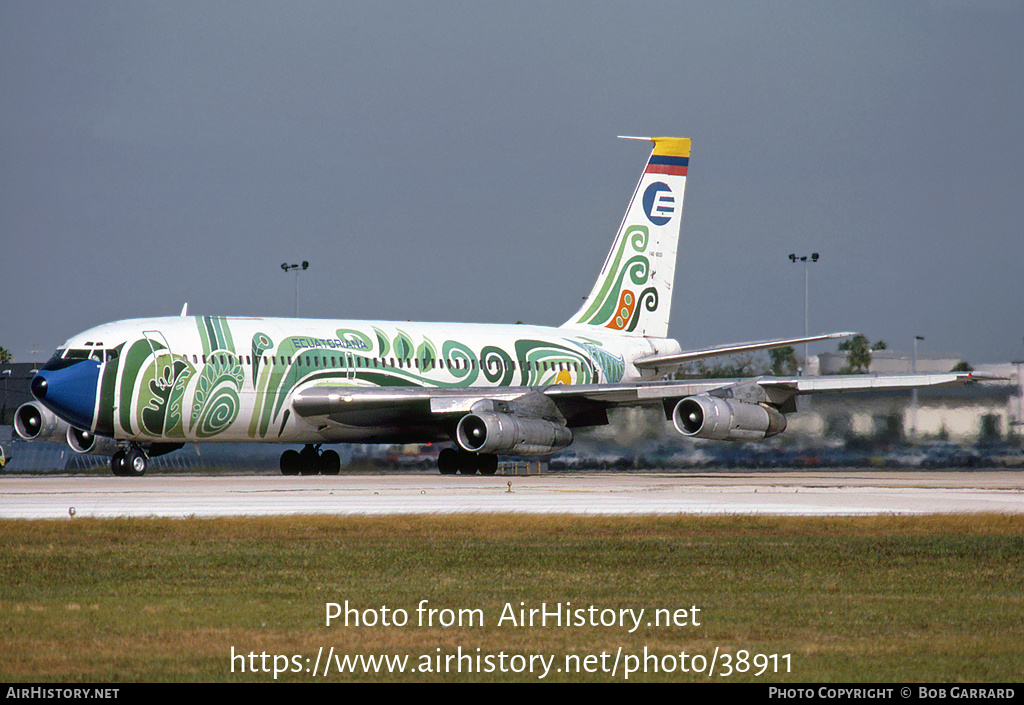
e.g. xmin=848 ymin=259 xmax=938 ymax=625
xmin=0 ymin=471 xmax=1024 ymax=519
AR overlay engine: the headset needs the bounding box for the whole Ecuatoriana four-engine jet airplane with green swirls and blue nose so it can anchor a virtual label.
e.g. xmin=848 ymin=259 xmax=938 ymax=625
xmin=15 ymin=137 xmax=978 ymax=476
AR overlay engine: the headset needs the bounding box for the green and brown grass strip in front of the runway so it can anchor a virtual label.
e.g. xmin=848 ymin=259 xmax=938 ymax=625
xmin=0 ymin=515 xmax=1024 ymax=682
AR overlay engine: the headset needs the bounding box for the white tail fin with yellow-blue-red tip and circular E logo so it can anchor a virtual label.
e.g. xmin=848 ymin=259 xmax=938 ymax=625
xmin=563 ymin=137 xmax=690 ymax=338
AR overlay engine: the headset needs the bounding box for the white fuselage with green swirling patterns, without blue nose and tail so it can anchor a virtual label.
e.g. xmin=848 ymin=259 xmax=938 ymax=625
xmin=57 ymin=317 xmax=679 ymax=443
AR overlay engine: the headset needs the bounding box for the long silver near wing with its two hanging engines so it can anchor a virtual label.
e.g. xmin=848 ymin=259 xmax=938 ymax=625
xmin=292 ymin=372 xmax=992 ymax=448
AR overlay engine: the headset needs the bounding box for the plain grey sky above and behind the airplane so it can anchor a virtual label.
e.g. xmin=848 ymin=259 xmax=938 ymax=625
xmin=0 ymin=0 xmax=1024 ymax=364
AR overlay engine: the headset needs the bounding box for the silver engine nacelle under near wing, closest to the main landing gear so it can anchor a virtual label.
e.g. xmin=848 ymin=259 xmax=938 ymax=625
xmin=456 ymin=411 xmax=572 ymax=455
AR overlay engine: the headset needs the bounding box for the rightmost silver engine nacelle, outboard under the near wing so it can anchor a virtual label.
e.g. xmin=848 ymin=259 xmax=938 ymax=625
xmin=672 ymin=395 xmax=785 ymax=441
